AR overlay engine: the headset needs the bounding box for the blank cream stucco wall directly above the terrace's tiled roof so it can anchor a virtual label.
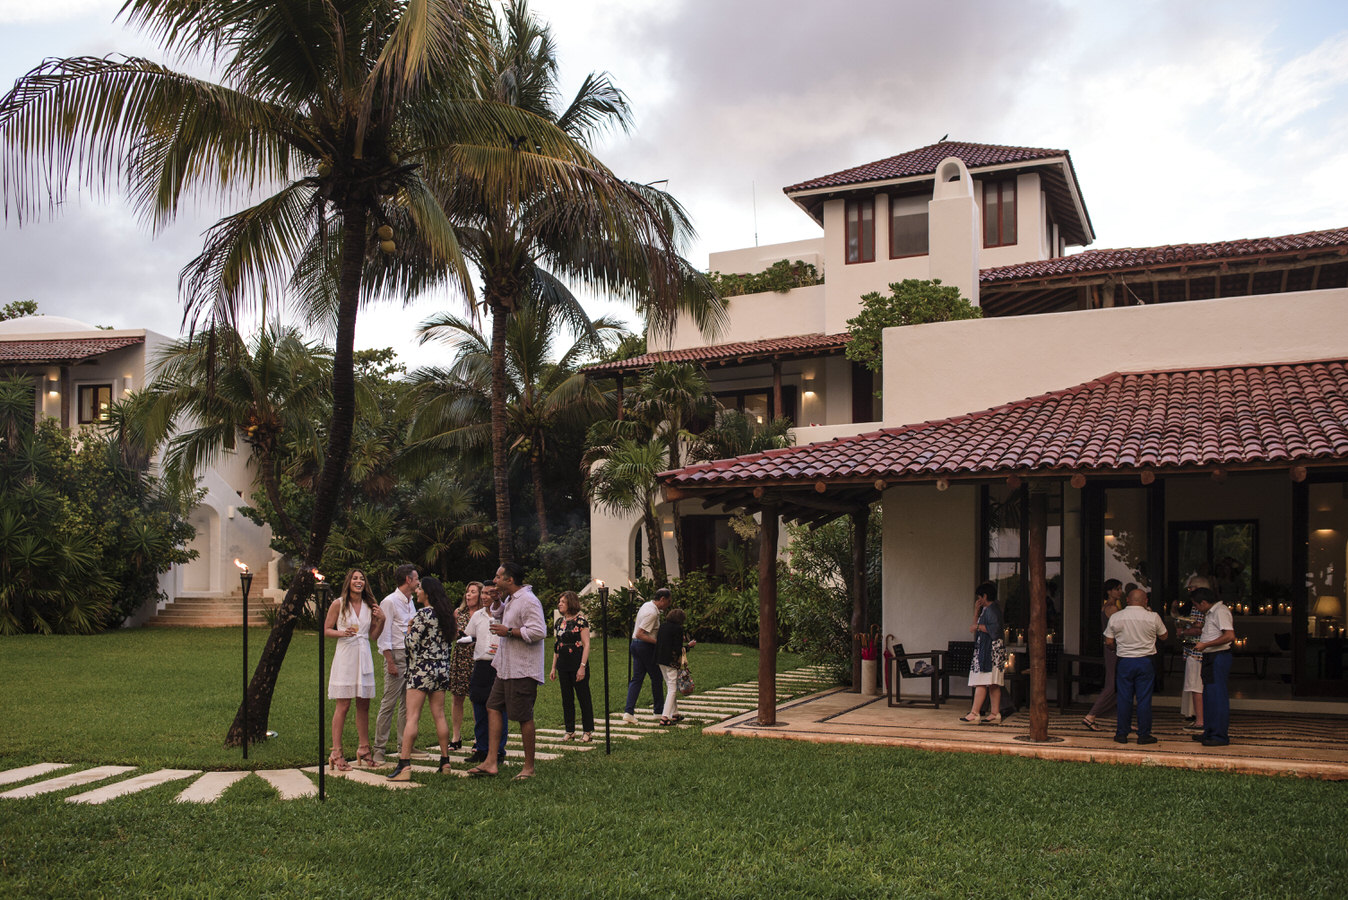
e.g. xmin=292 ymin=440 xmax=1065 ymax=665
xmin=884 ymin=288 xmax=1348 ymax=426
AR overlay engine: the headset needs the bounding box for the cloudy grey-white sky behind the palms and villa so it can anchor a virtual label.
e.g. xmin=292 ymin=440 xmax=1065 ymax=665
xmin=0 ymin=0 xmax=1348 ymax=364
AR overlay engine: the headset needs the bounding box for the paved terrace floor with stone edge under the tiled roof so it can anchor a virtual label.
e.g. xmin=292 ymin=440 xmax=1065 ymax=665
xmin=704 ymin=688 xmax=1348 ymax=780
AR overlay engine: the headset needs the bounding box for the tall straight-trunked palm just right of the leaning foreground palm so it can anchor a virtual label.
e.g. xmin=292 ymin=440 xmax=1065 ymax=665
xmin=446 ymin=0 xmax=724 ymax=559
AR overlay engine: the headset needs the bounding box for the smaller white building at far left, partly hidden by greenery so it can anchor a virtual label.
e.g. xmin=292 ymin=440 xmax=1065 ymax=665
xmin=0 ymin=315 xmax=280 ymax=625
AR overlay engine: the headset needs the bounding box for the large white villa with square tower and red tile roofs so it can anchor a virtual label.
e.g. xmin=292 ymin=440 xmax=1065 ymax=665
xmin=590 ymin=141 xmax=1348 ymax=705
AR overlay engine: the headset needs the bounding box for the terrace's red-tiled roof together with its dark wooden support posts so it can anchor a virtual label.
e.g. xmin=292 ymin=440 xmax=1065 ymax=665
xmin=661 ymin=358 xmax=1348 ymax=742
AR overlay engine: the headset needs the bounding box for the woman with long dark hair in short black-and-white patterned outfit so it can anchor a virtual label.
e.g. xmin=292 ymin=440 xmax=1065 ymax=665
xmin=388 ymin=575 xmax=458 ymax=781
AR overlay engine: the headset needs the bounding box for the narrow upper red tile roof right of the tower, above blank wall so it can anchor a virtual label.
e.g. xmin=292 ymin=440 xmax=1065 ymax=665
xmin=979 ymin=228 xmax=1348 ymax=284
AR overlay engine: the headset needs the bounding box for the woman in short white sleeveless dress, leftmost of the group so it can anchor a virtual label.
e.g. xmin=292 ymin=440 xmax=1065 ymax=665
xmin=324 ymin=569 xmax=384 ymax=772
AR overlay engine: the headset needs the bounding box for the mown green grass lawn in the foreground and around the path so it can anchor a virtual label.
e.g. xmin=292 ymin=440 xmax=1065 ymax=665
xmin=0 ymin=632 xmax=1348 ymax=899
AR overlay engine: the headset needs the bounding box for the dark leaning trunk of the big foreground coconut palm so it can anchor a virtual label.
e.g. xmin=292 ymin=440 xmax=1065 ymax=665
xmin=225 ymin=201 xmax=369 ymax=746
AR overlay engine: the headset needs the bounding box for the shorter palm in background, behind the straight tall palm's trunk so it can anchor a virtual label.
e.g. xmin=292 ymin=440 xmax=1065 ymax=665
xmin=408 ymin=299 xmax=624 ymax=543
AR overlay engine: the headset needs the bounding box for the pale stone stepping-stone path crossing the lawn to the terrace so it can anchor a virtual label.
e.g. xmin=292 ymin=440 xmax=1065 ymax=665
xmin=0 ymin=666 xmax=833 ymax=806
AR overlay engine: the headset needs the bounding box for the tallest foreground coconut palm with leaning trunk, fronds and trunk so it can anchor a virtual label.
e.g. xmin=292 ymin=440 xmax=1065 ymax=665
xmin=0 ymin=0 xmax=619 ymax=744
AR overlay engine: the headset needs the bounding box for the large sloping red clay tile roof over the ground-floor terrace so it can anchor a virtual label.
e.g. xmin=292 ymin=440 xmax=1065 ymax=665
xmin=662 ymin=360 xmax=1348 ymax=488
